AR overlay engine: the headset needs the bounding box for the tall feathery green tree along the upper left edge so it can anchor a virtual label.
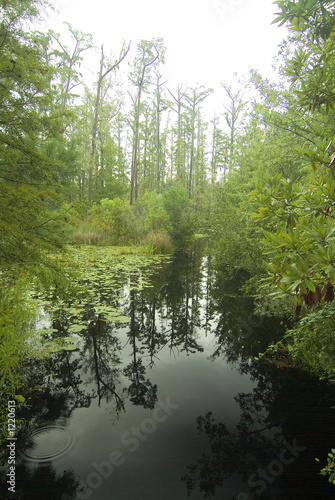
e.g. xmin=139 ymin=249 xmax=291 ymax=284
xmin=0 ymin=1 xmax=68 ymax=268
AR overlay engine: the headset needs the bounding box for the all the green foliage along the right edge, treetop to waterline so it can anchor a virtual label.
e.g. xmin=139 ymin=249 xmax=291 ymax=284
xmin=242 ymin=24 xmax=335 ymax=496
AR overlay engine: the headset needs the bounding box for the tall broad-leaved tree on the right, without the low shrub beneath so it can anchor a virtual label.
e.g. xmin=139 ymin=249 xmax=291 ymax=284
xmin=254 ymin=0 xmax=335 ymax=312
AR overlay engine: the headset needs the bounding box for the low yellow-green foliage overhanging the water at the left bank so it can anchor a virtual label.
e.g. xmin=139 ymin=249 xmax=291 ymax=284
xmin=0 ymin=255 xmax=83 ymax=394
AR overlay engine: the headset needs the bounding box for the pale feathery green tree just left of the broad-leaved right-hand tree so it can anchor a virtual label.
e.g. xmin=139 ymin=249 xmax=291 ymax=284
xmin=211 ymin=71 xmax=308 ymax=290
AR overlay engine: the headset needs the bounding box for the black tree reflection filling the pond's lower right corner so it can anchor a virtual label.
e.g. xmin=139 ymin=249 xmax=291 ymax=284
xmin=182 ymin=361 xmax=335 ymax=500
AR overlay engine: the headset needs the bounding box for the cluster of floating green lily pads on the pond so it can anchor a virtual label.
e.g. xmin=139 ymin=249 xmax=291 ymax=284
xmin=31 ymin=247 xmax=168 ymax=355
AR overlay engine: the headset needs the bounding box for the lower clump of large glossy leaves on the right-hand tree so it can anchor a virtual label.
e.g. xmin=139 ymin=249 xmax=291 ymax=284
xmin=251 ymin=160 xmax=335 ymax=305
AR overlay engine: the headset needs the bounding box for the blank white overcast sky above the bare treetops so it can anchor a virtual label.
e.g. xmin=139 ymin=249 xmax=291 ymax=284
xmin=44 ymin=0 xmax=286 ymax=89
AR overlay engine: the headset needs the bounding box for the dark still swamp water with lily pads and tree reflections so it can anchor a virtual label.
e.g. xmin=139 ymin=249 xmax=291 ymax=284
xmin=1 ymin=249 xmax=335 ymax=500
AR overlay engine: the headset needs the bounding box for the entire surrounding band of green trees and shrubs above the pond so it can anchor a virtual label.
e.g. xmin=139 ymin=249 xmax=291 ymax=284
xmin=0 ymin=0 xmax=335 ymax=476
